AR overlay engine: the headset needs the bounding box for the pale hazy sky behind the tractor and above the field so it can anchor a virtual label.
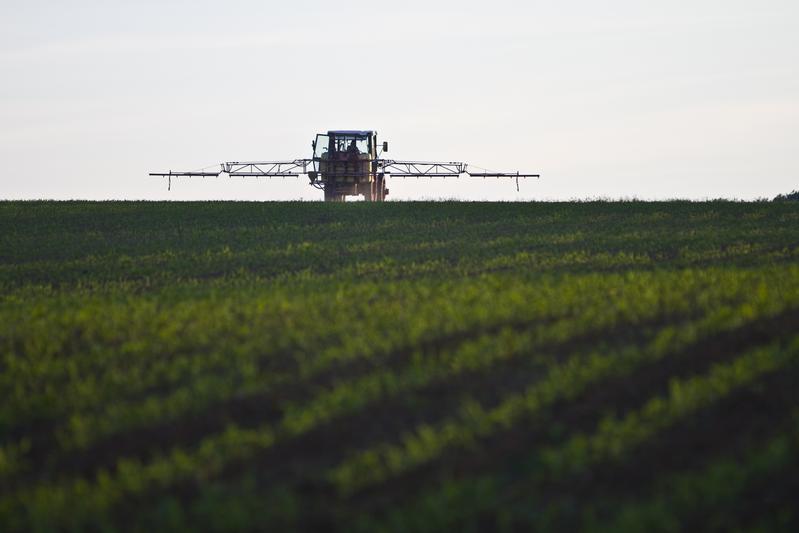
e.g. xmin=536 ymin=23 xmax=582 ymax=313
xmin=0 ymin=0 xmax=799 ymax=200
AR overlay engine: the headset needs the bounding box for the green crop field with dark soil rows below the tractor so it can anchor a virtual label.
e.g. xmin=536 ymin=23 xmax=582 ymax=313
xmin=0 ymin=201 xmax=799 ymax=532
